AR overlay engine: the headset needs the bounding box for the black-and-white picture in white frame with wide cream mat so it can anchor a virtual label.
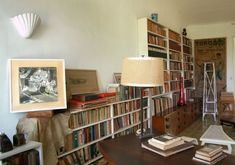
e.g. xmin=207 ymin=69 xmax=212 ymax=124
xmin=9 ymin=59 xmax=67 ymax=112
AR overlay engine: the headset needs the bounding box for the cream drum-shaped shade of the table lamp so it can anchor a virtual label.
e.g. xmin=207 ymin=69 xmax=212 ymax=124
xmin=121 ymin=57 xmax=164 ymax=87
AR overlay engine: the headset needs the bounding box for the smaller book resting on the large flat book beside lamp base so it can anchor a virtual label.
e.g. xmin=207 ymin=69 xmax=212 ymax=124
xmin=152 ymin=134 xmax=181 ymax=145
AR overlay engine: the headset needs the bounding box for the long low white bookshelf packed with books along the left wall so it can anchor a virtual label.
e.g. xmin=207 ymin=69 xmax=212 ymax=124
xmin=58 ymin=93 xmax=149 ymax=165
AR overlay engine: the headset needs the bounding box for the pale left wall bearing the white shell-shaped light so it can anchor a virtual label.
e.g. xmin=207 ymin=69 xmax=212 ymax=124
xmin=0 ymin=0 xmax=182 ymax=137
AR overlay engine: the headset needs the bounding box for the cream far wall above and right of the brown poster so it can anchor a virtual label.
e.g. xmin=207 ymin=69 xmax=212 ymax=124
xmin=187 ymin=23 xmax=235 ymax=92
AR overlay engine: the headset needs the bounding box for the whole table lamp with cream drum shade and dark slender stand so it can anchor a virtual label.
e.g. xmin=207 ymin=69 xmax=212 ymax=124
xmin=121 ymin=57 xmax=164 ymax=139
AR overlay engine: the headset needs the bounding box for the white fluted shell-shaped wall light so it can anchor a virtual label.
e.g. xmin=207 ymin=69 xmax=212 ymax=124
xmin=11 ymin=13 xmax=41 ymax=38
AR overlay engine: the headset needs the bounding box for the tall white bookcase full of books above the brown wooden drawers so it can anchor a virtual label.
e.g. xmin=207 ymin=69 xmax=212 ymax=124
xmin=138 ymin=18 xmax=194 ymax=100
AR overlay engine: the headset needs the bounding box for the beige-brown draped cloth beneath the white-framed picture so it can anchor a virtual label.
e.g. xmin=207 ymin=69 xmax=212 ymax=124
xmin=16 ymin=113 xmax=72 ymax=165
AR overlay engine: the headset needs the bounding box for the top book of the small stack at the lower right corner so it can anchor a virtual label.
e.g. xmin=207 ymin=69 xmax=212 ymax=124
xmin=196 ymin=144 xmax=222 ymax=157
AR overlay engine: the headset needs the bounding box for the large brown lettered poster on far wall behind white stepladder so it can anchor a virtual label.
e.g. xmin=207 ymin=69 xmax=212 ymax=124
xmin=194 ymin=38 xmax=227 ymax=97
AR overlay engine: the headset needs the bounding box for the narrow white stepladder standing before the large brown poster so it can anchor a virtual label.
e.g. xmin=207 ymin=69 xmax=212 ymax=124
xmin=202 ymin=62 xmax=218 ymax=121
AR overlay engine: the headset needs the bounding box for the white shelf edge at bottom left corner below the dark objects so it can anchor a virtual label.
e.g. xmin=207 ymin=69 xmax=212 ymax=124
xmin=0 ymin=141 xmax=43 ymax=165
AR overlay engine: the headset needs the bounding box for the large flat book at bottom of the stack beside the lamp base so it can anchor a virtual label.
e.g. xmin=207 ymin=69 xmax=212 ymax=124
xmin=141 ymin=141 xmax=194 ymax=157
